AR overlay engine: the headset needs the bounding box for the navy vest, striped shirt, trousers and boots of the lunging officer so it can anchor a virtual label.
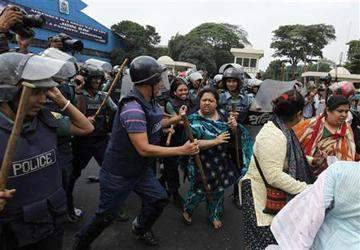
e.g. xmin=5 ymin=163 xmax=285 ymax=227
xmin=74 ymin=89 xmax=168 ymax=245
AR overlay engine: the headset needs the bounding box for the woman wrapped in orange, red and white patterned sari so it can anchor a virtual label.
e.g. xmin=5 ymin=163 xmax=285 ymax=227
xmin=294 ymin=95 xmax=356 ymax=174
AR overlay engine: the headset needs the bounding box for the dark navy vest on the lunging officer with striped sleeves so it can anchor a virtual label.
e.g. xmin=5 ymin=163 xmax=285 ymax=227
xmin=102 ymin=88 xmax=163 ymax=177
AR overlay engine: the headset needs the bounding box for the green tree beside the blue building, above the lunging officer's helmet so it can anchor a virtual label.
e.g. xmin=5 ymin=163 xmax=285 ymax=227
xmin=111 ymin=21 xmax=161 ymax=64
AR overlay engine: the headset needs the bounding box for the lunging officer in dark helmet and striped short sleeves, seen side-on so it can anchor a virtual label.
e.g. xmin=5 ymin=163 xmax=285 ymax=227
xmin=74 ymin=56 xmax=199 ymax=249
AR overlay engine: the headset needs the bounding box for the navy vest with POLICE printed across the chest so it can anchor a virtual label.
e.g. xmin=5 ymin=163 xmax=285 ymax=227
xmin=0 ymin=110 xmax=66 ymax=246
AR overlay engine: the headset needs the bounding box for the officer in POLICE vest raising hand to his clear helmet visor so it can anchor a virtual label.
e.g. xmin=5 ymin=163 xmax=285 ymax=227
xmin=0 ymin=53 xmax=93 ymax=250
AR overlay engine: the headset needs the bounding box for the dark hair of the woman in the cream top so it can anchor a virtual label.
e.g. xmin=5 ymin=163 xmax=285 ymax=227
xmin=273 ymin=90 xmax=305 ymax=121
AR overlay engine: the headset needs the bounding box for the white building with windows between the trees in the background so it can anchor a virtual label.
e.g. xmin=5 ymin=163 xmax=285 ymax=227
xmin=230 ymin=48 xmax=264 ymax=78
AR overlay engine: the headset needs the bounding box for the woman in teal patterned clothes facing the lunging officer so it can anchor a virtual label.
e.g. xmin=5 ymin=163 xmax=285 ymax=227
xmin=182 ymin=88 xmax=252 ymax=229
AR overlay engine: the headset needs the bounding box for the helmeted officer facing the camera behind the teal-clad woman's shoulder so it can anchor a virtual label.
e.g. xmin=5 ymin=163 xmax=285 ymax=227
xmin=220 ymin=67 xmax=251 ymax=208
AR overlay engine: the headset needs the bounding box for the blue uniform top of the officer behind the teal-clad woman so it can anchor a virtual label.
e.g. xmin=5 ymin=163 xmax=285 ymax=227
xmin=220 ymin=91 xmax=251 ymax=123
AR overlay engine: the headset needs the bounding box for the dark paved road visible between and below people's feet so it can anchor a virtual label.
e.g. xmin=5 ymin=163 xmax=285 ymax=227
xmin=64 ymin=160 xmax=244 ymax=250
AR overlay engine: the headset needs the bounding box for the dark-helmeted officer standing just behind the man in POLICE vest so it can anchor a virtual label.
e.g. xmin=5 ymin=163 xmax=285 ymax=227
xmin=66 ymin=64 xmax=117 ymax=217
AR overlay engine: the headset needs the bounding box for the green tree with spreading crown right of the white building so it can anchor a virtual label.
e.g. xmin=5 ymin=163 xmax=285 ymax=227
xmin=270 ymin=24 xmax=336 ymax=78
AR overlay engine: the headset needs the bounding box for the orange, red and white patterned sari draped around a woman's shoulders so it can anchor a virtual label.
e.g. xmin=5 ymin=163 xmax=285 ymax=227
xmin=294 ymin=116 xmax=356 ymax=161
